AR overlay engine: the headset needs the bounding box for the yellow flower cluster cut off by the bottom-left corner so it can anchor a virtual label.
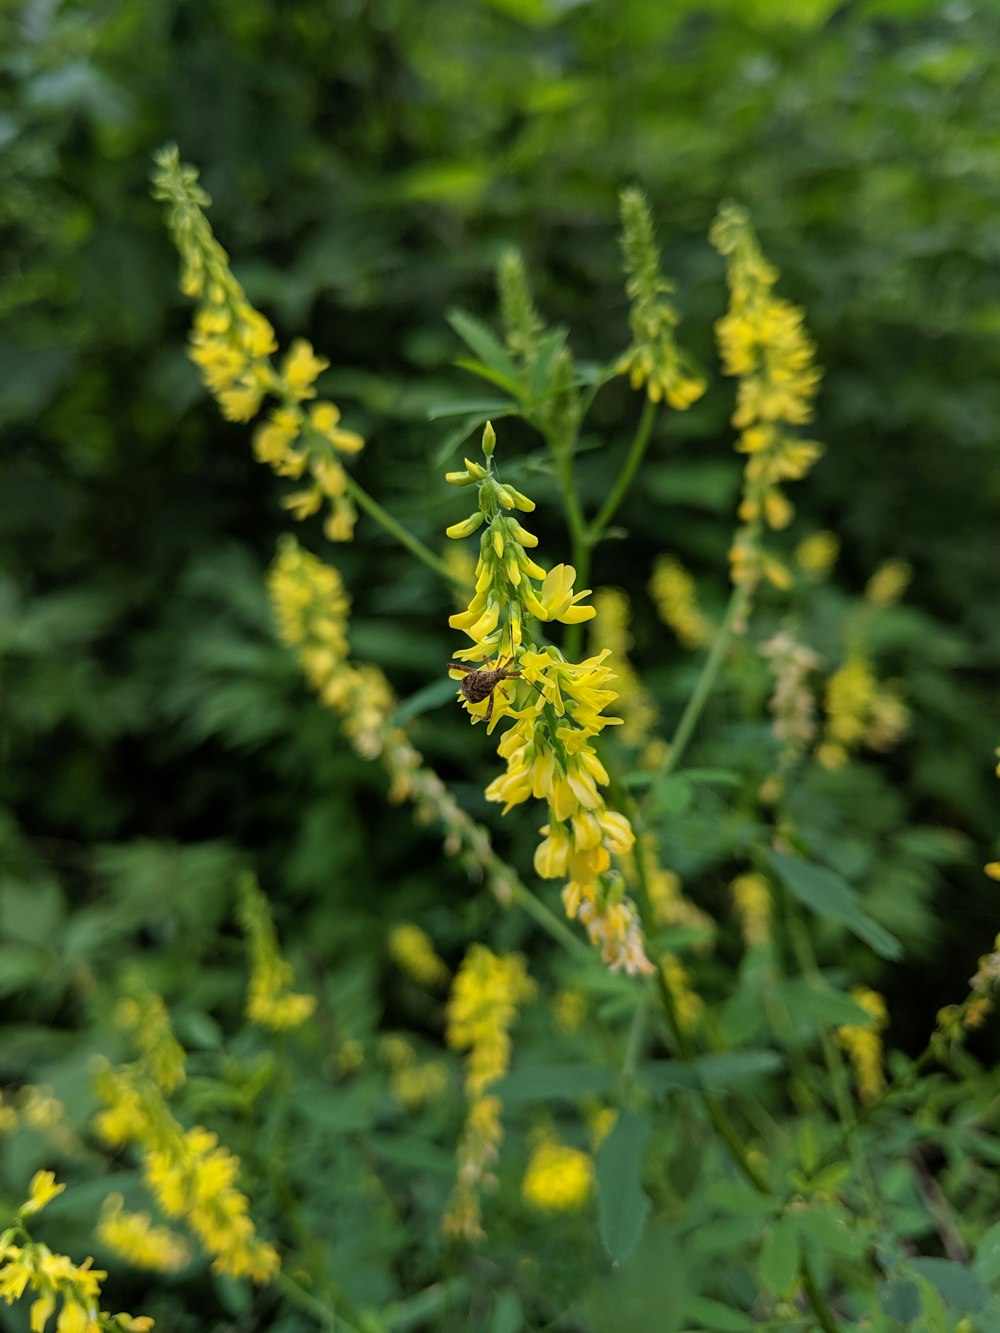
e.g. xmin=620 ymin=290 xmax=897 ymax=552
xmin=0 ymin=1170 xmax=153 ymax=1333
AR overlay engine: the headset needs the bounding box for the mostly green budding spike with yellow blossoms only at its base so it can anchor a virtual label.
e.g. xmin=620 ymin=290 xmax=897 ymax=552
xmin=615 ymin=189 xmax=705 ymax=412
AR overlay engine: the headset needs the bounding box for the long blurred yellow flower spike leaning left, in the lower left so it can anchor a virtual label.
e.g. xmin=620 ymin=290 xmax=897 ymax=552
xmin=95 ymin=996 xmax=279 ymax=1282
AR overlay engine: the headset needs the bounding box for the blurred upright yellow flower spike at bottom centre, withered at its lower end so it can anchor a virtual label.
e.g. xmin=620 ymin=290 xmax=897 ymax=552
xmin=441 ymin=944 xmax=535 ymax=1240
